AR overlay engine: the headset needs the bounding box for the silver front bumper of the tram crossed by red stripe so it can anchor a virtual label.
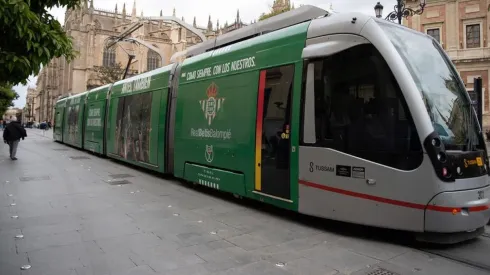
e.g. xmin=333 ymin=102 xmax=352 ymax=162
xmin=425 ymin=186 xmax=490 ymax=233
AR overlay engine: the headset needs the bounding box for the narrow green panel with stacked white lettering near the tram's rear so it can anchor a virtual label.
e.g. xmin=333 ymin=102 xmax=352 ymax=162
xmin=84 ymin=85 xmax=110 ymax=154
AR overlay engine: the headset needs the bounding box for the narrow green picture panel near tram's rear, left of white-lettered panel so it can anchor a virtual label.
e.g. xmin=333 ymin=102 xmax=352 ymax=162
xmin=63 ymin=93 xmax=87 ymax=148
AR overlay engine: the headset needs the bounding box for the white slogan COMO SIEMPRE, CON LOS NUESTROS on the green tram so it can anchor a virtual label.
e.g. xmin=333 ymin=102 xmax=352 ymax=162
xmin=186 ymin=56 xmax=256 ymax=81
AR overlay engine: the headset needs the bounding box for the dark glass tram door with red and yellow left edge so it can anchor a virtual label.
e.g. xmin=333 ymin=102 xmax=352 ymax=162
xmin=255 ymin=65 xmax=294 ymax=199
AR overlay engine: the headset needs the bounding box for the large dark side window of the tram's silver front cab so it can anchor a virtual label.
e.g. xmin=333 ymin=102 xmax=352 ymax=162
xmin=303 ymin=45 xmax=423 ymax=170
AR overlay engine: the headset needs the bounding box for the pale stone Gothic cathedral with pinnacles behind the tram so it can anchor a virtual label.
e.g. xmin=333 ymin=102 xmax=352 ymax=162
xmin=24 ymin=0 xmax=249 ymax=122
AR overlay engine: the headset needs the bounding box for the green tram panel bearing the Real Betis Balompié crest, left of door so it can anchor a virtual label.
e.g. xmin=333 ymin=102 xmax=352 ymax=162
xmin=174 ymin=65 xmax=258 ymax=196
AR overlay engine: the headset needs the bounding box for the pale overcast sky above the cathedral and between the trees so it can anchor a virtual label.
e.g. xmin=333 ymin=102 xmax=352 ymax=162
xmin=14 ymin=0 xmax=396 ymax=108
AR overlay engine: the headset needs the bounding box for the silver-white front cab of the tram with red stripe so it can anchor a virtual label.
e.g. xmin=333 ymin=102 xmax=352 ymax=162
xmin=299 ymin=14 xmax=490 ymax=242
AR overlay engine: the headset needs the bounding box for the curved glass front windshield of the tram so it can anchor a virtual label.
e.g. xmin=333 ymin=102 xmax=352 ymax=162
xmin=378 ymin=22 xmax=479 ymax=150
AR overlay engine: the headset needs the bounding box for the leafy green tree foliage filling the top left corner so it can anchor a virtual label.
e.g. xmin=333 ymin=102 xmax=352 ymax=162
xmin=0 ymin=0 xmax=80 ymax=111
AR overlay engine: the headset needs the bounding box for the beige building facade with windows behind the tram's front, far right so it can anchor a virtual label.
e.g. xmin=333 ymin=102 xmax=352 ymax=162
xmin=403 ymin=0 xmax=490 ymax=127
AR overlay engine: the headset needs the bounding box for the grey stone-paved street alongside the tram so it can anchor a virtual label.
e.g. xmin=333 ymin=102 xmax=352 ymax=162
xmin=0 ymin=129 xmax=488 ymax=275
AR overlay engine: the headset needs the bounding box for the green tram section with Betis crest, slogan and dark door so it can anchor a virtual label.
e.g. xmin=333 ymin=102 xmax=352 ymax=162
xmin=174 ymin=23 xmax=308 ymax=210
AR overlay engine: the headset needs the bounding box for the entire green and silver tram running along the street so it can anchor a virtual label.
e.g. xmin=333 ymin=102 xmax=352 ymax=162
xmin=54 ymin=6 xmax=490 ymax=242
